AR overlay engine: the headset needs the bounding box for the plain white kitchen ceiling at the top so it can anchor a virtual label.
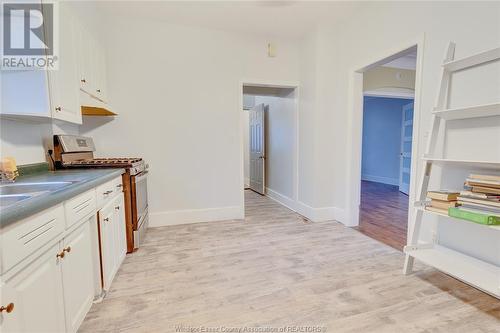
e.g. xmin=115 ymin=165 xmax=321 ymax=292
xmin=90 ymin=1 xmax=360 ymax=38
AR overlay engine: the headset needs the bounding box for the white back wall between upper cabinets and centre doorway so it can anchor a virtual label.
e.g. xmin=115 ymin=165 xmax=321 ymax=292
xmin=81 ymin=18 xmax=299 ymax=225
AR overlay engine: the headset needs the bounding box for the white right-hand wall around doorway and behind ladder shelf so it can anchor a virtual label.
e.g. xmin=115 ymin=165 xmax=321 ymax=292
xmin=299 ymin=2 xmax=500 ymax=263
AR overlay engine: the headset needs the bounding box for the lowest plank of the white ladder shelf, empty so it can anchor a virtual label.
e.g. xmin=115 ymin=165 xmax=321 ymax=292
xmin=405 ymin=245 xmax=500 ymax=298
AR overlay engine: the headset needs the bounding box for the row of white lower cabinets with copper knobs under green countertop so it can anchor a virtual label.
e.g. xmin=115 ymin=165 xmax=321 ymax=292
xmin=0 ymin=176 xmax=126 ymax=333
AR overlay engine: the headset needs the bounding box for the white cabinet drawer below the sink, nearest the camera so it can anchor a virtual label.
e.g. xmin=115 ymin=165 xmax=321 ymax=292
xmin=1 ymin=204 xmax=64 ymax=273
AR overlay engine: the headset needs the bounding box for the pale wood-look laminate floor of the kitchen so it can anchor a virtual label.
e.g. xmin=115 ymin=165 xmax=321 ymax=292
xmin=80 ymin=191 xmax=500 ymax=333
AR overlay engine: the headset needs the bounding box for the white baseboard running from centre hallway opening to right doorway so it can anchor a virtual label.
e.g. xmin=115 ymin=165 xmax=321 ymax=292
xmin=266 ymin=188 xmax=346 ymax=224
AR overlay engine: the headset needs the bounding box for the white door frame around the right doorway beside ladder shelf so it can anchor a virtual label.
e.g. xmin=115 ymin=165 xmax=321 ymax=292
xmin=345 ymin=34 xmax=425 ymax=232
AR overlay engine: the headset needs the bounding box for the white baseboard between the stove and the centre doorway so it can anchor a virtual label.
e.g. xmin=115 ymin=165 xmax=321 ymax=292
xmin=149 ymin=206 xmax=245 ymax=228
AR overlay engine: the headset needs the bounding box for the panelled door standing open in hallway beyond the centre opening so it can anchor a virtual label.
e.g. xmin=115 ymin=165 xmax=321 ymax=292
xmin=249 ymin=104 xmax=266 ymax=194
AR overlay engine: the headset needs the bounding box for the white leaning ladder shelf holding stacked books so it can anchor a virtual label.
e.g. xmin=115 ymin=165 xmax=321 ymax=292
xmin=404 ymin=43 xmax=500 ymax=299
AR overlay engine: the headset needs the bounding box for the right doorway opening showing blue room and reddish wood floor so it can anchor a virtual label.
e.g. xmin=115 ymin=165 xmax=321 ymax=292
xmin=351 ymin=43 xmax=421 ymax=251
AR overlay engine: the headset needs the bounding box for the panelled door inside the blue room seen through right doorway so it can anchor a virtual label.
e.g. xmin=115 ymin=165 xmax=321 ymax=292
xmin=399 ymin=102 xmax=413 ymax=195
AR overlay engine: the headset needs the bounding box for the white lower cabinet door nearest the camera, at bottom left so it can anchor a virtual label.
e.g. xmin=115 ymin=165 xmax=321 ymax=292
xmin=0 ymin=244 xmax=65 ymax=333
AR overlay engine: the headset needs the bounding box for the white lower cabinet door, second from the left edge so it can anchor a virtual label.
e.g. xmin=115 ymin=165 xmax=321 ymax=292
xmin=62 ymin=219 xmax=94 ymax=332
